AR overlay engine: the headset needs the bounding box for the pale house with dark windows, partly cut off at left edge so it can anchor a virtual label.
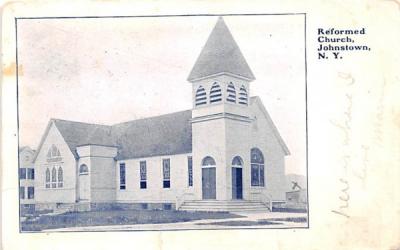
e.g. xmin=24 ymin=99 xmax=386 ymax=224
xmin=19 ymin=147 xmax=35 ymax=214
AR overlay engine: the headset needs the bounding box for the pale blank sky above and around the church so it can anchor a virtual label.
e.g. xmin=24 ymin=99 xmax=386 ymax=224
xmin=18 ymin=15 xmax=306 ymax=175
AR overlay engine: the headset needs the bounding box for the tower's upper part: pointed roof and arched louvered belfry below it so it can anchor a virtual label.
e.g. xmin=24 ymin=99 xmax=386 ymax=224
xmin=188 ymin=17 xmax=255 ymax=109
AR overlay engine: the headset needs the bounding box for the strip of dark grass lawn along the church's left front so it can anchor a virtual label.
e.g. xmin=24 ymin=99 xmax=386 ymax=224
xmin=21 ymin=210 xmax=242 ymax=231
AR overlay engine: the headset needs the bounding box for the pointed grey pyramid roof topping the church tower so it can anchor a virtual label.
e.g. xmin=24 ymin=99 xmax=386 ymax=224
xmin=188 ymin=17 xmax=255 ymax=81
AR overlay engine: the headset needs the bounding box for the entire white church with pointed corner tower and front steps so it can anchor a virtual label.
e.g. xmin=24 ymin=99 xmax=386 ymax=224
xmin=34 ymin=18 xmax=289 ymax=211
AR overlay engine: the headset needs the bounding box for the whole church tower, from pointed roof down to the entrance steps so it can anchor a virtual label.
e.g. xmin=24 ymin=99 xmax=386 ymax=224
xmin=188 ymin=17 xmax=255 ymax=200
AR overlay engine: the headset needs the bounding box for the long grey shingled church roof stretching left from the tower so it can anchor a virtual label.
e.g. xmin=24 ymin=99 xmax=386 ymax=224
xmin=34 ymin=110 xmax=192 ymax=160
